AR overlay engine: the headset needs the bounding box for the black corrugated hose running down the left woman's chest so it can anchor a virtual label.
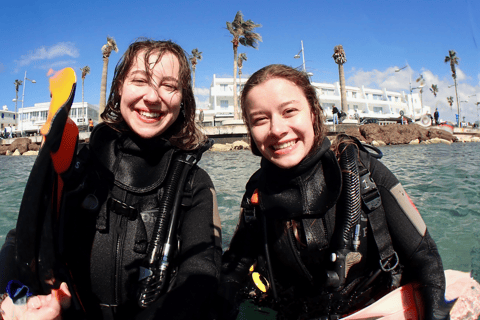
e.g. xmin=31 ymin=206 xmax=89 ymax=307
xmin=138 ymin=150 xmax=201 ymax=308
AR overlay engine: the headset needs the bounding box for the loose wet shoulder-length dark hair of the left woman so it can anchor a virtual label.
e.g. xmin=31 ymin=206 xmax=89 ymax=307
xmin=101 ymin=38 xmax=206 ymax=150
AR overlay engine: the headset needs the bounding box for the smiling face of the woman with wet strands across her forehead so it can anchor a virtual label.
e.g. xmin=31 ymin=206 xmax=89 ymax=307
xmin=119 ymin=51 xmax=182 ymax=139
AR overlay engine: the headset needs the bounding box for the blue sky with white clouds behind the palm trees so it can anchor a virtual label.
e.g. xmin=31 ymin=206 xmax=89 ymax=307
xmin=0 ymin=0 xmax=480 ymax=121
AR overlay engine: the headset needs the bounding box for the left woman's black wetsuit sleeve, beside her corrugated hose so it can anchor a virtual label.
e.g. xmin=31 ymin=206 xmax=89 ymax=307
xmin=136 ymin=169 xmax=222 ymax=320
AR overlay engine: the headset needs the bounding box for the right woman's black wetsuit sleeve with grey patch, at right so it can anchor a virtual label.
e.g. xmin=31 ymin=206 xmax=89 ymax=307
xmin=370 ymin=154 xmax=448 ymax=319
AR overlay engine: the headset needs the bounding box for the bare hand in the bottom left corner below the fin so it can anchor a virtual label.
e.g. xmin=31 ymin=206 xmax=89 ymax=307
xmin=0 ymin=283 xmax=72 ymax=320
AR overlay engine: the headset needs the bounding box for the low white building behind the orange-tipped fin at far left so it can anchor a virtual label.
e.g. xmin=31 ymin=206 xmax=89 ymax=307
xmin=16 ymin=102 xmax=98 ymax=135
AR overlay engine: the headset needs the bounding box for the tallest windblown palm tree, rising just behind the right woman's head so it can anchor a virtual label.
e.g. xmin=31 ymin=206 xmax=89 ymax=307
xmin=227 ymin=11 xmax=262 ymax=119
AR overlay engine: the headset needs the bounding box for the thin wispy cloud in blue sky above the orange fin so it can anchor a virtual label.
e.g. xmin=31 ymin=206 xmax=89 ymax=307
xmin=15 ymin=42 xmax=80 ymax=67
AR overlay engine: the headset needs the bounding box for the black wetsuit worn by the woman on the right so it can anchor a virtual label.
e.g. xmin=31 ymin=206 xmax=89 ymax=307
xmin=221 ymin=139 xmax=445 ymax=319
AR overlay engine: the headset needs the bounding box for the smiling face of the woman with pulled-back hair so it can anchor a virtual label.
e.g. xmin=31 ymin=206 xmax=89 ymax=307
xmin=245 ymin=78 xmax=315 ymax=169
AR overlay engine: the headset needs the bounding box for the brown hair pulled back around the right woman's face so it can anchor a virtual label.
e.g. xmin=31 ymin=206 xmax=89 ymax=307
xmin=240 ymin=64 xmax=327 ymax=156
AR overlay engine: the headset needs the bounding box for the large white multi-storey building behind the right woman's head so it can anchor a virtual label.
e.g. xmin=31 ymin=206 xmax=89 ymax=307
xmin=204 ymin=74 xmax=431 ymax=123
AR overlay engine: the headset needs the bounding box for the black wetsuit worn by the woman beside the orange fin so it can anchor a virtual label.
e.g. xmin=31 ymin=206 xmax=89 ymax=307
xmin=2 ymin=125 xmax=221 ymax=319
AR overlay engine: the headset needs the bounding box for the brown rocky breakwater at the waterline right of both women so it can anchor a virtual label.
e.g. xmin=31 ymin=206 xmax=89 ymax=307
xmin=345 ymin=123 xmax=464 ymax=146
